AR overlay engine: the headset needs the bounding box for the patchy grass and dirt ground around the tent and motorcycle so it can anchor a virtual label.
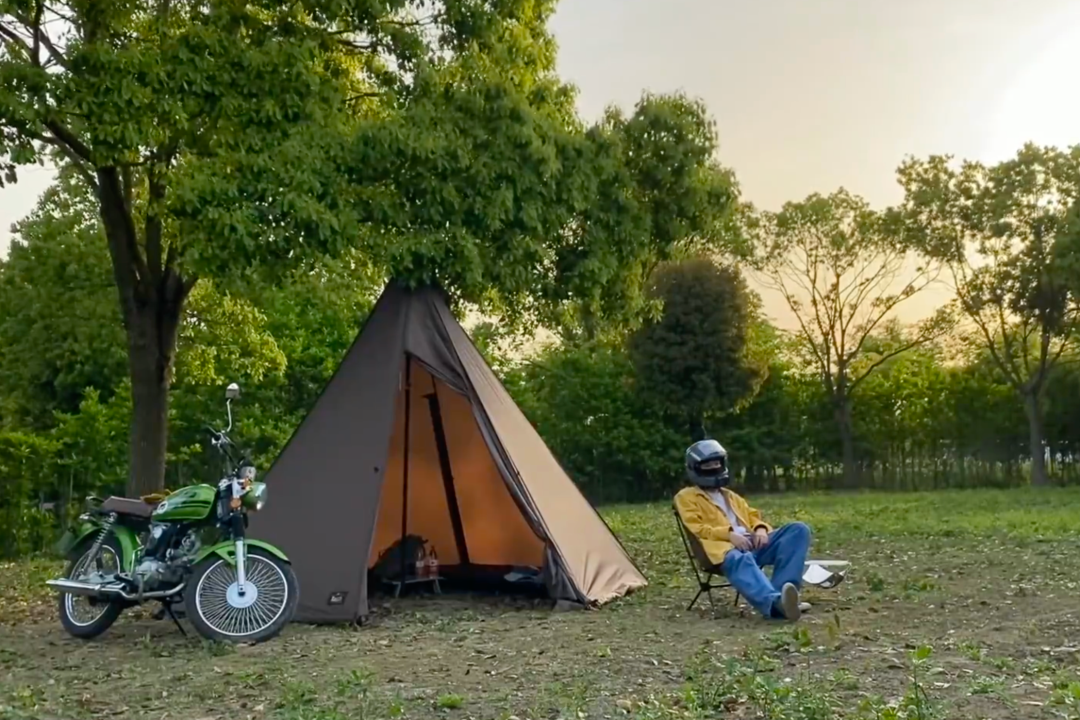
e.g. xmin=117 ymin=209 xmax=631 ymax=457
xmin=0 ymin=489 xmax=1080 ymax=720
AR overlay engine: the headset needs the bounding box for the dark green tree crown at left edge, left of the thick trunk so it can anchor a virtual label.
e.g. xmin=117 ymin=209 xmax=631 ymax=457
xmin=0 ymin=174 xmax=126 ymax=430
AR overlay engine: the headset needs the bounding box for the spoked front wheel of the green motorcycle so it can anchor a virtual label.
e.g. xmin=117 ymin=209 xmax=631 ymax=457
xmin=184 ymin=547 xmax=300 ymax=642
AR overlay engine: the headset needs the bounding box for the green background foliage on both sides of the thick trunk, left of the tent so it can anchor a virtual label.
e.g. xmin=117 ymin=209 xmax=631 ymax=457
xmin=0 ymin=162 xmax=380 ymax=546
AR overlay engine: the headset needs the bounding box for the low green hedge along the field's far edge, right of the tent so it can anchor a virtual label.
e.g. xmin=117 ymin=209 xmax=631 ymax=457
xmin=505 ymin=325 xmax=1080 ymax=502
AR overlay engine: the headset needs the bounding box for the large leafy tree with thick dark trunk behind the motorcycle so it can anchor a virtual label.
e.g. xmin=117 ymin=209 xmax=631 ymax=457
xmin=0 ymin=0 xmax=591 ymax=493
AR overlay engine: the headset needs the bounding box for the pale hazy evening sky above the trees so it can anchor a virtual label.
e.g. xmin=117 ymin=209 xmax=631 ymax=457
xmin=0 ymin=0 xmax=1080 ymax=324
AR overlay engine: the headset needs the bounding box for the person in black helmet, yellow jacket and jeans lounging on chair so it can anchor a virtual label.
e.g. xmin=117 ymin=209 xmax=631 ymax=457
xmin=675 ymin=439 xmax=810 ymax=621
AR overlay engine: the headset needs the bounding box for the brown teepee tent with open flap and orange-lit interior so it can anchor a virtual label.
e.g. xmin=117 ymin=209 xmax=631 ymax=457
xmin=251 ymin=283 xmax=646 ymax=622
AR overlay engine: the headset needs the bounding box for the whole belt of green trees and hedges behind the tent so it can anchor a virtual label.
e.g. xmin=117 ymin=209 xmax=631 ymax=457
xmin=0 ymin=0 xmax=1080 ymax=546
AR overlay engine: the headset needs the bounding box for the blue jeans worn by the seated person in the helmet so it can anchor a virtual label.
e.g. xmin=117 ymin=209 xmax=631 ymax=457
xmin=720 ymin=522 xmax=810 ymax=617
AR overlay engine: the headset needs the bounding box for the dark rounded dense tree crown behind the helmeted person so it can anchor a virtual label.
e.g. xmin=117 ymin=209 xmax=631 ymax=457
xmin=630 ymin=258 xmax=765 ymax=435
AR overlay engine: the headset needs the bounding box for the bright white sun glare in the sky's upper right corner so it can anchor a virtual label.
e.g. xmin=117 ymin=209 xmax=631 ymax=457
xmin=982 ymin=8 xmax=1080 ymax=162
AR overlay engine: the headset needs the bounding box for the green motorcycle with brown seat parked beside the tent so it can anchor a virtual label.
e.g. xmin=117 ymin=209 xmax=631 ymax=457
xmin=48 ymin=383 xmax=299 ymax=642
